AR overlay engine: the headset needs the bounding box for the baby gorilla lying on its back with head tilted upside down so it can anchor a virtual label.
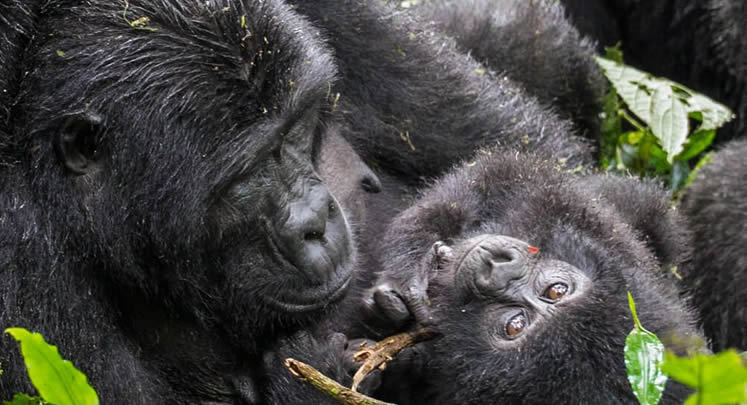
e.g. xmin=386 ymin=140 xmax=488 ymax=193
xmin=363 ymin=151 xmax=700 ymax=405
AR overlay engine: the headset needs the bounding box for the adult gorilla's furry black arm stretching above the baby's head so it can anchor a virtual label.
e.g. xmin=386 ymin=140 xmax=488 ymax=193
xmin=291 ymin=0 xmax=593 ymax=182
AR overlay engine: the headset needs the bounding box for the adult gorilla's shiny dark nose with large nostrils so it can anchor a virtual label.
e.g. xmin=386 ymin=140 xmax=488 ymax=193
xmin=278 ymin=183 xmax=349 ymax=283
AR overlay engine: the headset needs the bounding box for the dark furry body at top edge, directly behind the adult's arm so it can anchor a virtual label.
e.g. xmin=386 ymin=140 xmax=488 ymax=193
xmin=415 ymin=0 xmax=606 ymax=140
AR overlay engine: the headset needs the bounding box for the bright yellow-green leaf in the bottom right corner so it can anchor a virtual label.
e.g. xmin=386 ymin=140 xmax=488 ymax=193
xmin=662 ymin=350 xmax=747 ymax=405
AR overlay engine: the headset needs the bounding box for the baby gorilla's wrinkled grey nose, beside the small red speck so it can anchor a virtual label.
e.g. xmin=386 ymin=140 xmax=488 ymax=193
xmin=461 ymin=235 xmax=531 ymax=294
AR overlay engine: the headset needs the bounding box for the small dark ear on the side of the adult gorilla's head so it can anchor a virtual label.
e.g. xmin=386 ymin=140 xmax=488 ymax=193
xmin=55 ymin=112 xmax=104 ymax=174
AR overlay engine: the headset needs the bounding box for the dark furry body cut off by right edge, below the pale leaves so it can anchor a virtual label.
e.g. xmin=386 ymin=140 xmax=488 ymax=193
xmin=680 ymin=140 xmax=747 ymax=351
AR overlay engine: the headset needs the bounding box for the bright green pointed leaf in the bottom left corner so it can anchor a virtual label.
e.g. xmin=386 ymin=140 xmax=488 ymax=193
xmin=5 ymin=328 xmax=99 ymax=405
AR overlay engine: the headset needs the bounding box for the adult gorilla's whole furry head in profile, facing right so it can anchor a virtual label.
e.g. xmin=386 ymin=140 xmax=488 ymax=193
xmin=15 ymin=0 xmax=354 ymax=345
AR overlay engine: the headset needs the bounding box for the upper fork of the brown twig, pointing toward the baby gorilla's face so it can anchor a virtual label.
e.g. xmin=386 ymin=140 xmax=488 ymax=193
xmin=351 ymin=328 xmax=438 ymax=392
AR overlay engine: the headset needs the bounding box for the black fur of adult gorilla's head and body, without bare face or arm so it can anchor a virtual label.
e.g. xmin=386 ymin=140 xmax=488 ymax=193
xmin=0 ymin=0 xmax=352 ymax=404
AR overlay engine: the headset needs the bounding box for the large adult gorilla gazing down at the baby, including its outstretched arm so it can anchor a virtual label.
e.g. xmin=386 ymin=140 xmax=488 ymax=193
xmin=0 ymin=0 xmax=591 ymax=404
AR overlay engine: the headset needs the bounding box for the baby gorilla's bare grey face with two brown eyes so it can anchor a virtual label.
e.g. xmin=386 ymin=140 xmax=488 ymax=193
xmin=429 ymin=234 xmax=591 ymax=349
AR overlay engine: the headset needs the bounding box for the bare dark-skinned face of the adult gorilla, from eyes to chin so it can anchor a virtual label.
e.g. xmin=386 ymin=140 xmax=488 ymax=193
xmin=219 ymin=106 xmax=353 ymax=314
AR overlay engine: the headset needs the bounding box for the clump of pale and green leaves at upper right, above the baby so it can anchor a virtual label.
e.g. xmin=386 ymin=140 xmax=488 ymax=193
xmin=597 ymin=47 xmax=734 ymax=190
